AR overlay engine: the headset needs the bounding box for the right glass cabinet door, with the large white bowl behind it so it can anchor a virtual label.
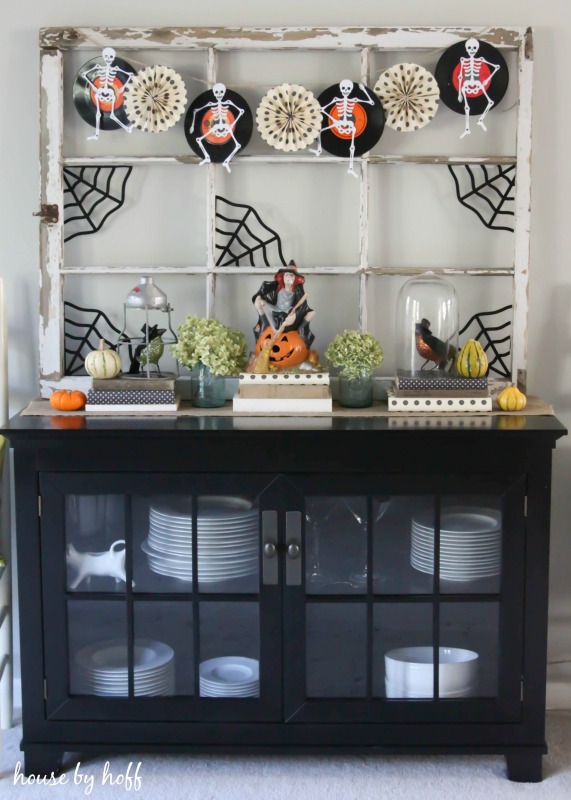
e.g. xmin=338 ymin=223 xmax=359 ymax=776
xmin=284 ymin=475 xmax=525 ymax=722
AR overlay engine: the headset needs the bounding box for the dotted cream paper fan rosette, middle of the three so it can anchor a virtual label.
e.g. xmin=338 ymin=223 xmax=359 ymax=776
xmin=256 ymin=83 xmax=321 ymax=152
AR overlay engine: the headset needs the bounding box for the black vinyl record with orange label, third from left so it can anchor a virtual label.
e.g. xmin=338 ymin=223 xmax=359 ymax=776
xmin=317 ymin=81 xmax=385 ymax=158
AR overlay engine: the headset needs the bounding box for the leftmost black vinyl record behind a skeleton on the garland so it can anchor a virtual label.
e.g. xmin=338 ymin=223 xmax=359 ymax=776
xmin=73 ymin=56 xmax=137 ymax=131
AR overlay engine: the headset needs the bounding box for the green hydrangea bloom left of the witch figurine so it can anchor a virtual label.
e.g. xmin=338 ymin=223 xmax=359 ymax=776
xmin=171 ymin=314 xmax=246 ymax=375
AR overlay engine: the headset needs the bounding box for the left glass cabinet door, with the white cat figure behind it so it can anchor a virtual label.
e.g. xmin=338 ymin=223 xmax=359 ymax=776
xmin=41 ymin=474 xmax=281 ymax=720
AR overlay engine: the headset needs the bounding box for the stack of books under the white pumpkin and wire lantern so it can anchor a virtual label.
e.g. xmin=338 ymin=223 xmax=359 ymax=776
xmin=85 ymin=377 xmax=180 ymax=413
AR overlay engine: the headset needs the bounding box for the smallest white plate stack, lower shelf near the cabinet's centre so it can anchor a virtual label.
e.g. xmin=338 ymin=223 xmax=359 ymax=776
xmin=200 ymin=656 xmax=260 ymax=697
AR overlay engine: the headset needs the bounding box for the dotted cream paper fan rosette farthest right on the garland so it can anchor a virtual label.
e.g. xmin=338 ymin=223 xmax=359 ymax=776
xmin=374 ymin=64 xmax=440 ymax=132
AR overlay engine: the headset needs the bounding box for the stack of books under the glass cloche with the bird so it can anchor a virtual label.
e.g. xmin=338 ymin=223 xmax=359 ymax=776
xmin=387 ymin=372 xmax=492 ymax=414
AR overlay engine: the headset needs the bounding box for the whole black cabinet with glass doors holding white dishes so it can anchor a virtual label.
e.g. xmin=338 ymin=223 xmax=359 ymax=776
xmin=6 ymin=417 xmax=565 ymax=780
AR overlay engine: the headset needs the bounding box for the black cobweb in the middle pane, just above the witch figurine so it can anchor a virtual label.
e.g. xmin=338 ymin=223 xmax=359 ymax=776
xmin=216 ymin=197 xmax=286 ymax=267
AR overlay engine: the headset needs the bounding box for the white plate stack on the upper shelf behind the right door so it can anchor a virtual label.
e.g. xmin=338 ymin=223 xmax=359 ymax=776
xmin=410 ymin=506 xmax=502 ymax=581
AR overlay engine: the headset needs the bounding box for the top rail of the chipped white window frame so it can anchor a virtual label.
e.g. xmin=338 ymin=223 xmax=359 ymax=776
xmin=40 ymin=26 xmax=525 ymax=50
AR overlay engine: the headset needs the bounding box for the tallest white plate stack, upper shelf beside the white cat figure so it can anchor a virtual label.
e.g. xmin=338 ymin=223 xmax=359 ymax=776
xmin=142 ymin=496 xmax=259 ymax=583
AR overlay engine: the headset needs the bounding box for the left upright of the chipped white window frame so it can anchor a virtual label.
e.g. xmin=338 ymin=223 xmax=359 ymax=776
xmin=39 ymin=51 xmax=63 ymax=394
